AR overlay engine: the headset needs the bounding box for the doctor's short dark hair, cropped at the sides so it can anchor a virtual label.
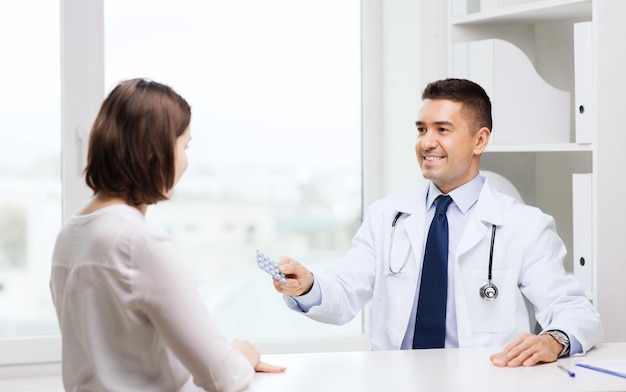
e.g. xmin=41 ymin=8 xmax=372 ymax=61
xmin=422 ymin=78 xmax=493 ymax=132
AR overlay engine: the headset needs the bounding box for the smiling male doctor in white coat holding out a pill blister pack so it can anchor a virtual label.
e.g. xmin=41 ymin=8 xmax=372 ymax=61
xmin=274 ymin=79 xmax=602 ymax=367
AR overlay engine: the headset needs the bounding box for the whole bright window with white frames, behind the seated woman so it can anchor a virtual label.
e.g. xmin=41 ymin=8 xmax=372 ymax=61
xmin=0 ymin=0 xmax=382 ymax=365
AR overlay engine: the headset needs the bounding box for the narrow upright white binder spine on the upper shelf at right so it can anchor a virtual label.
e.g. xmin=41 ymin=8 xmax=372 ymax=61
xmin=574 ymin=22 xmax=593 ymax=144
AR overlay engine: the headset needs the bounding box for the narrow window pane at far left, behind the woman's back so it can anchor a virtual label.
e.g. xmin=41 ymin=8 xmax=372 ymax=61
xmin=0 ymin=0 xmax=62 ymax=338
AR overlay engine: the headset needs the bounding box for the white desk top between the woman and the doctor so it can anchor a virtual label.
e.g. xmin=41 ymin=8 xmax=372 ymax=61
xmin=253 ymin=343 xmax=626 ymax=392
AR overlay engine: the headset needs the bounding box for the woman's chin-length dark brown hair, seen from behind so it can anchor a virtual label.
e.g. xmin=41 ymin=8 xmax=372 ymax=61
xmin=84 ymin=79 xmax=191 ymax=205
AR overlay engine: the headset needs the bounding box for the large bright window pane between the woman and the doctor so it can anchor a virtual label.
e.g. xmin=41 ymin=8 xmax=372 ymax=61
xmin=105 ymin=0 xmax=363 ymax=339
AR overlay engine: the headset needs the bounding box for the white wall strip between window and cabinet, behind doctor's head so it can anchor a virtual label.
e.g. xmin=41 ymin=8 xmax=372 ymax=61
xmin=381 ymin=0 xmax=448 ymax=195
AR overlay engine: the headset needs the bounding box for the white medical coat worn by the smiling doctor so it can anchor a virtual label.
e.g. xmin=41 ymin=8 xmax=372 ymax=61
xmin=290 ymin=180 xmax=602 ymax=352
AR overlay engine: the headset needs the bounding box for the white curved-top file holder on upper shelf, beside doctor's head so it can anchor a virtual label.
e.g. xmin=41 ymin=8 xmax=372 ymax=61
xmin=452 ymin=39 xmax=571 ymax=144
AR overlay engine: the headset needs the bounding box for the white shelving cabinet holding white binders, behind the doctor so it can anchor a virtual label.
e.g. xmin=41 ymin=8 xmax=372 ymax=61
xmin=447 ymin=0 xmax=626 ymax=341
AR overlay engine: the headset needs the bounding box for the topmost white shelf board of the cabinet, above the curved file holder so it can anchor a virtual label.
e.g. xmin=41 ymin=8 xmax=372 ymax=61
xmin=450 ymin=0 xmax=592 ymax=25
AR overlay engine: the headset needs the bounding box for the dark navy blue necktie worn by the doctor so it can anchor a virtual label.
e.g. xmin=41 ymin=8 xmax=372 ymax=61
xmin=413 ymin=195 xmax=452 ymax=348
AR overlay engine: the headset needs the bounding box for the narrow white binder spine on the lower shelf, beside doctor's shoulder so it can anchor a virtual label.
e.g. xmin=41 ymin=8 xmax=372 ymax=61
xmin=572 ymin=173 xmax=593 ymax=299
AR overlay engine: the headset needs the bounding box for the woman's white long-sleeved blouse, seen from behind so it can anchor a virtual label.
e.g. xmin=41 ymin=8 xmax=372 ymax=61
xmin=50 ymin=205 xmax=254 ymax=391
